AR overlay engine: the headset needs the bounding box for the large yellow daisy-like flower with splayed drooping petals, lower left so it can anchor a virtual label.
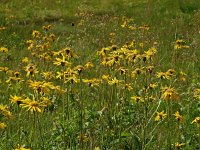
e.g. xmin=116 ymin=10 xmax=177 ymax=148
xmin=20 ymin=96 xmax=46 ymax=113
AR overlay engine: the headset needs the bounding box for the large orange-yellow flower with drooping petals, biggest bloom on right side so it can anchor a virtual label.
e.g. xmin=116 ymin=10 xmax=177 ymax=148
xmin=162 ymin=87 xmax=179 ymax=100
